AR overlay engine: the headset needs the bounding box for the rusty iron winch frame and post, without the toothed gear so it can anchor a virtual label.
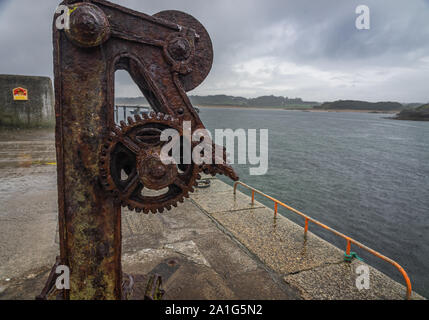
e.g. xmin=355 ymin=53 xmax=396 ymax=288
xmin=53 ymin=0 xmax=238 ymax=299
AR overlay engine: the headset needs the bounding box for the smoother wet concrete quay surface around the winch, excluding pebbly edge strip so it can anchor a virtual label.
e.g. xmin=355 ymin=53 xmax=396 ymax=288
xmin=0 ymin=132 xmax=300 ymax=299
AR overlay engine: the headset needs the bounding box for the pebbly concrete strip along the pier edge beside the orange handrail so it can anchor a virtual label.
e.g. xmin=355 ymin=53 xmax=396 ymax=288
xmin=195 ymin=180 xmax=422 ymax=300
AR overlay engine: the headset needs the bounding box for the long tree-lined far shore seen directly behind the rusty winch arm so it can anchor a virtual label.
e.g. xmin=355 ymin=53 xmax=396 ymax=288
xmin=116 ymin=94 xmax=320 ymax=108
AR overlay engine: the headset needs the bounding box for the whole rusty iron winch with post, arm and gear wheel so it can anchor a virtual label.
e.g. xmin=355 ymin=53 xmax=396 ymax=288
xmin=39 ymin=0 xmax=238 ymax=299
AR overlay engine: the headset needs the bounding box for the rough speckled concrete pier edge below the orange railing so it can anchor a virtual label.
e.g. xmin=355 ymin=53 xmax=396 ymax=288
xmin=191 ymin=177 xmax=425 ymax=300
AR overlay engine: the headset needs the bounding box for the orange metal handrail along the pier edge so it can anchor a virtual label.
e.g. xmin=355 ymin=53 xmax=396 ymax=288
xmin=234 ymin=181 xmax=412 ymax=300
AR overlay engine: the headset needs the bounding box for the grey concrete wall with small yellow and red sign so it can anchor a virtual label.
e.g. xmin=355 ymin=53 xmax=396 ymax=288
xmin=0 ymin=75 xmax=55 ymax=128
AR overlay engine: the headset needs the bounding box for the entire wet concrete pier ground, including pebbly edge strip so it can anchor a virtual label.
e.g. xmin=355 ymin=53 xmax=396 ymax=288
xmin=0 ymin=132 xmax=420 ymax=299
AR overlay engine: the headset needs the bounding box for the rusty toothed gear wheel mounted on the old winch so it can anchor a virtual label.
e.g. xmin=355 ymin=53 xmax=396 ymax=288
xmin=100 ymin=112 xmax=201 ymax=213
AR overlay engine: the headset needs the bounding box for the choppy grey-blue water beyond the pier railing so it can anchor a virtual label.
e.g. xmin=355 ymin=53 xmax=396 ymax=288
xmin=200 ymin=108 xmax=429 ymax=297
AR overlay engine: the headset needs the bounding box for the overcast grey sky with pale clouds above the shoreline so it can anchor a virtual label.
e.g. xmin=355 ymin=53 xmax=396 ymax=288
xmin=0 ymin=0 xmax=429 ymax=102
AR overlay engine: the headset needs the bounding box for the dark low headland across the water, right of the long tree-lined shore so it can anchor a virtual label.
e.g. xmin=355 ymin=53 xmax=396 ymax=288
xmin=314 ymin=100 xmax=404 ymax=111
